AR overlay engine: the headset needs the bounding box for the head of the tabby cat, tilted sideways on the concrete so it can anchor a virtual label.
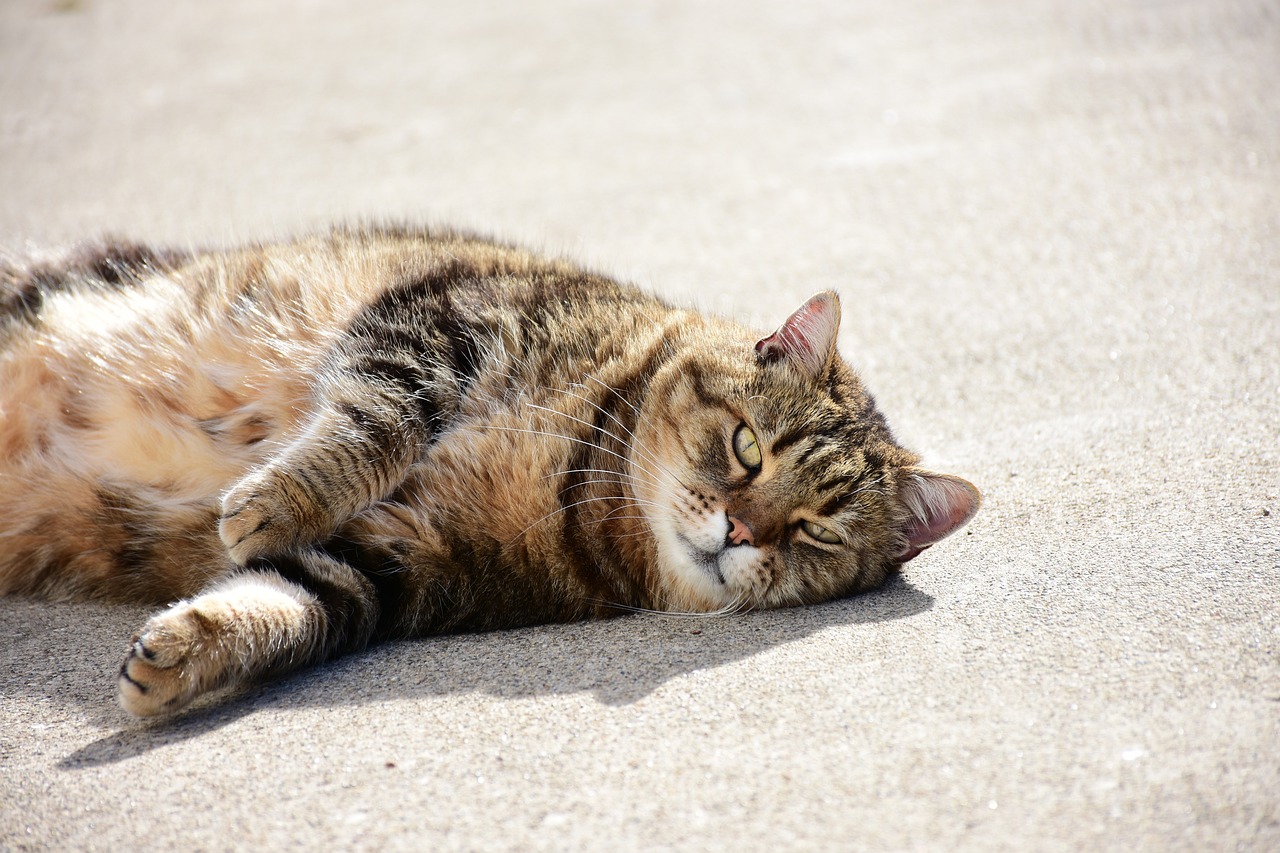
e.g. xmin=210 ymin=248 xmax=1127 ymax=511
xmin=631 ymin=292 xmax=980 ymax=611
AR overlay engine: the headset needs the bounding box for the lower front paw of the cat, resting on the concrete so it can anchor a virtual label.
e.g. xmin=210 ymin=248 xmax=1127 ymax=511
xmin=116 ymin=603 xmax=209 ymax=717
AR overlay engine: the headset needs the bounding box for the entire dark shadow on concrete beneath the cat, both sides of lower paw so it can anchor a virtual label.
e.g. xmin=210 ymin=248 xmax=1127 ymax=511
xmin=0 ymin=578 xmax=933 ymax=770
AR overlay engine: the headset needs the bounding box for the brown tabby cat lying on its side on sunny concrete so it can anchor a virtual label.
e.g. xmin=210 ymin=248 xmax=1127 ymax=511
xmin=0 ymin=227 xmax=980 ymax=716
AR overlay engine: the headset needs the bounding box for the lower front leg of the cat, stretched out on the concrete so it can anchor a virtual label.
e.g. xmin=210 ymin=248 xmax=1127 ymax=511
xmin=118 ymin=551 xmax=379 ymax=717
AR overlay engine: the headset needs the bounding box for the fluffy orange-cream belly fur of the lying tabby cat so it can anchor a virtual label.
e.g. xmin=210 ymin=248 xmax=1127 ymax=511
xmin=0 ymin=286 xmax=317 ymax=601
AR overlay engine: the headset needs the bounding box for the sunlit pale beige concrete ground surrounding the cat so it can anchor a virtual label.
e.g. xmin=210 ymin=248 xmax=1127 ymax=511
xmin=0 ymin=0 xmax=1280 ymax=850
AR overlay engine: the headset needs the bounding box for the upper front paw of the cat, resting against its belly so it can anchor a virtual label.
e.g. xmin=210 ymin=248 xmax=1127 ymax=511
xmin=218 ymin=469 xmax=307 ymax=566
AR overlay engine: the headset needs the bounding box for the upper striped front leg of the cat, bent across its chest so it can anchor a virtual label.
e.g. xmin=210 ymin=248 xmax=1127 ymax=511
xmin=219 ymin=275 xmax=489 ymax=565
